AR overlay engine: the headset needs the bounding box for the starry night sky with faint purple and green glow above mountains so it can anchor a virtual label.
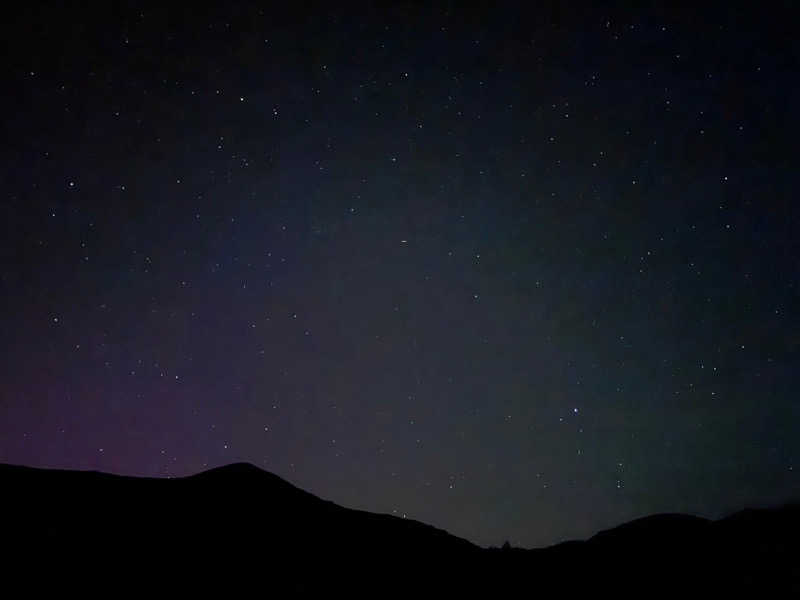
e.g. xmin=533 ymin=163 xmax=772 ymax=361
xmin=0 ymin=2 xmax=800 ymax=546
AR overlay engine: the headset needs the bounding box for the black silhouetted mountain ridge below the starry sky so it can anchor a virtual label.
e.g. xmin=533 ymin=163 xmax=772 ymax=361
xmin=0 ymin=464 xmax=800 ymax=597
